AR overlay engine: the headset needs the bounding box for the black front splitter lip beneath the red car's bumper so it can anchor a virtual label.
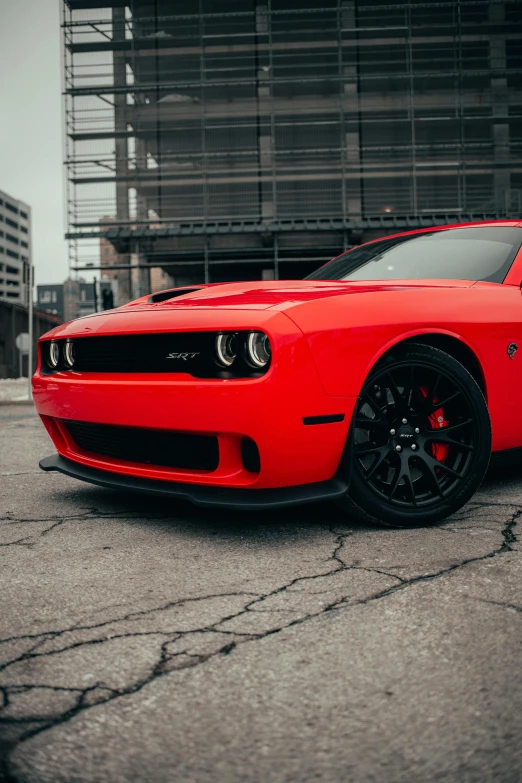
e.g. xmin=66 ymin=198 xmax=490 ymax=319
xmin=40 ymin=454 xmax=348 ymax=511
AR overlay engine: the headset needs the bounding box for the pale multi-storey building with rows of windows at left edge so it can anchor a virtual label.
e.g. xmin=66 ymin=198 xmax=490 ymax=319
xmin=0 ymin=190 xmax=31 ymax=306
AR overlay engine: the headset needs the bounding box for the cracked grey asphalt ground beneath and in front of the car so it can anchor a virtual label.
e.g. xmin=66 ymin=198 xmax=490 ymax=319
xmin=0 ymin=405 xmax=522 ymax=783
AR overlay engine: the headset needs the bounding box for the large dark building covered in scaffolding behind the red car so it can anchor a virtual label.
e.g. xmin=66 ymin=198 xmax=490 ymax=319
xmin=63 ymin=0 xmax=522 ymax=301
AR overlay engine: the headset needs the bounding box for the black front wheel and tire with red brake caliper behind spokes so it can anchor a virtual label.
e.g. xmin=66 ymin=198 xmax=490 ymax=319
xmin=341 ymin=344 xmax=491 ymax=527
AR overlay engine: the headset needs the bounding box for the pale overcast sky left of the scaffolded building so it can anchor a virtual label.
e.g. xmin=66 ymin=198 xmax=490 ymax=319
xmin=0 ymin=0 xmax=67 ymax=283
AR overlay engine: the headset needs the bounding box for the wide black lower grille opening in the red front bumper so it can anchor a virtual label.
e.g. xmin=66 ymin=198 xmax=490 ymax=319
xmin=63 ymin=421 xmax=219 ymax=471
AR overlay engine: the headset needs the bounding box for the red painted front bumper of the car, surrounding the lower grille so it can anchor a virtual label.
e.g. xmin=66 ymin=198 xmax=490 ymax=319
xmin=33 ymin=313 xmax=356 ymax=491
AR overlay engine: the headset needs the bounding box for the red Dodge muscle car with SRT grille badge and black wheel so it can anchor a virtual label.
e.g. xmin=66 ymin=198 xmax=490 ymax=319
xmin=33 ymin=221 xmax=522 ymax=526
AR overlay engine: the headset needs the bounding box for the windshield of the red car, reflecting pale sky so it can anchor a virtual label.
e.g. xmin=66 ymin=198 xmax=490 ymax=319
xmin=306 ymin=226 xmax=522 ymax=283
